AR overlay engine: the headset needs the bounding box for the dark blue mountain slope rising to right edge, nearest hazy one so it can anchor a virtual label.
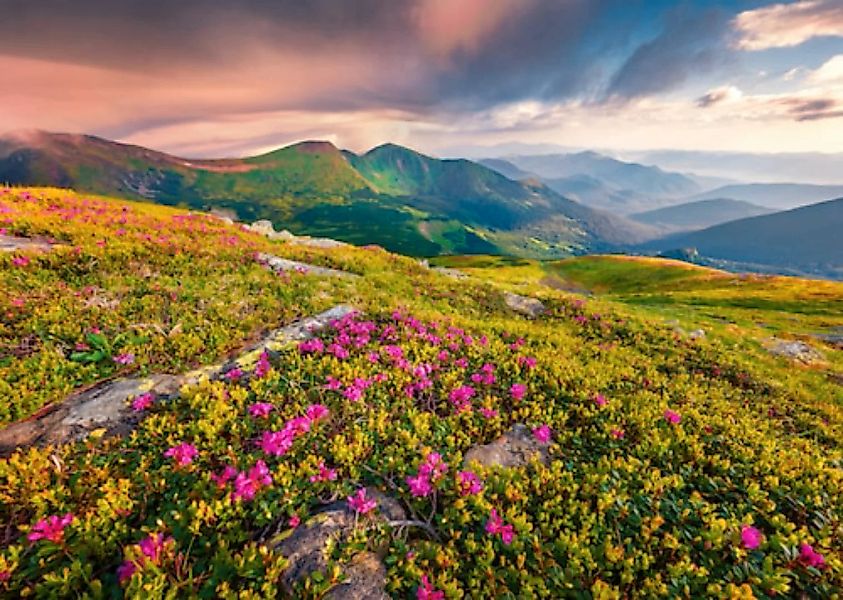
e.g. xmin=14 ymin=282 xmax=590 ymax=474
xmin=645 ymin=198 xmax=843 ymax=279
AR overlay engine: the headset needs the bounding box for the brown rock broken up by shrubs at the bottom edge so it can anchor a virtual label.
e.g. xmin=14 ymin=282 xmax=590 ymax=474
xmin=269 ymin=488 xmax=406 ymax=600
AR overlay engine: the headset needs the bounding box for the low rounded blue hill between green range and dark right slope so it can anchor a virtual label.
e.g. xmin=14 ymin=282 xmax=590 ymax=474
xmin=629 ymin=198 xmax=775 ymax=230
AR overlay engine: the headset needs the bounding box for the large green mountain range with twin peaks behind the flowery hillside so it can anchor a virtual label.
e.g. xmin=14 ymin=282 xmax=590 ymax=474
xmin=0 ymin=132 xmax=657 ymax=257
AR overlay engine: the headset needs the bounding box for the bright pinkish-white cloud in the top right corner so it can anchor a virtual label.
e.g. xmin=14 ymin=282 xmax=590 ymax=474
xmin=733 ymin=0 xmax=843 ymax=50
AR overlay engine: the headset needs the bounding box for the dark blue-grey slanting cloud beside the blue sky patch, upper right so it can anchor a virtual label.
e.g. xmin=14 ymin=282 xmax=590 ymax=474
xmin=608 ymin=10 xmax=728 ymax=98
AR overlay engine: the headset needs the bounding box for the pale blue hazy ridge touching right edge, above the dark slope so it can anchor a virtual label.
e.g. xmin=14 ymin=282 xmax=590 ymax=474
xmin=691 ymin=183 xmax=843 ymax=209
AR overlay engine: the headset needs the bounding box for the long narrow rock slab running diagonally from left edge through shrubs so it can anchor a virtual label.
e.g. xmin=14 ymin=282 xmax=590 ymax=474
xmin=0 ymin=305 xmax=355 ymax=456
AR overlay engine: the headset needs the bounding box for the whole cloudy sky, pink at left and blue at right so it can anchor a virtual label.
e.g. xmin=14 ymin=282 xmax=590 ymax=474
xmin=0 ymin=0 xmax=843 ymax=157
